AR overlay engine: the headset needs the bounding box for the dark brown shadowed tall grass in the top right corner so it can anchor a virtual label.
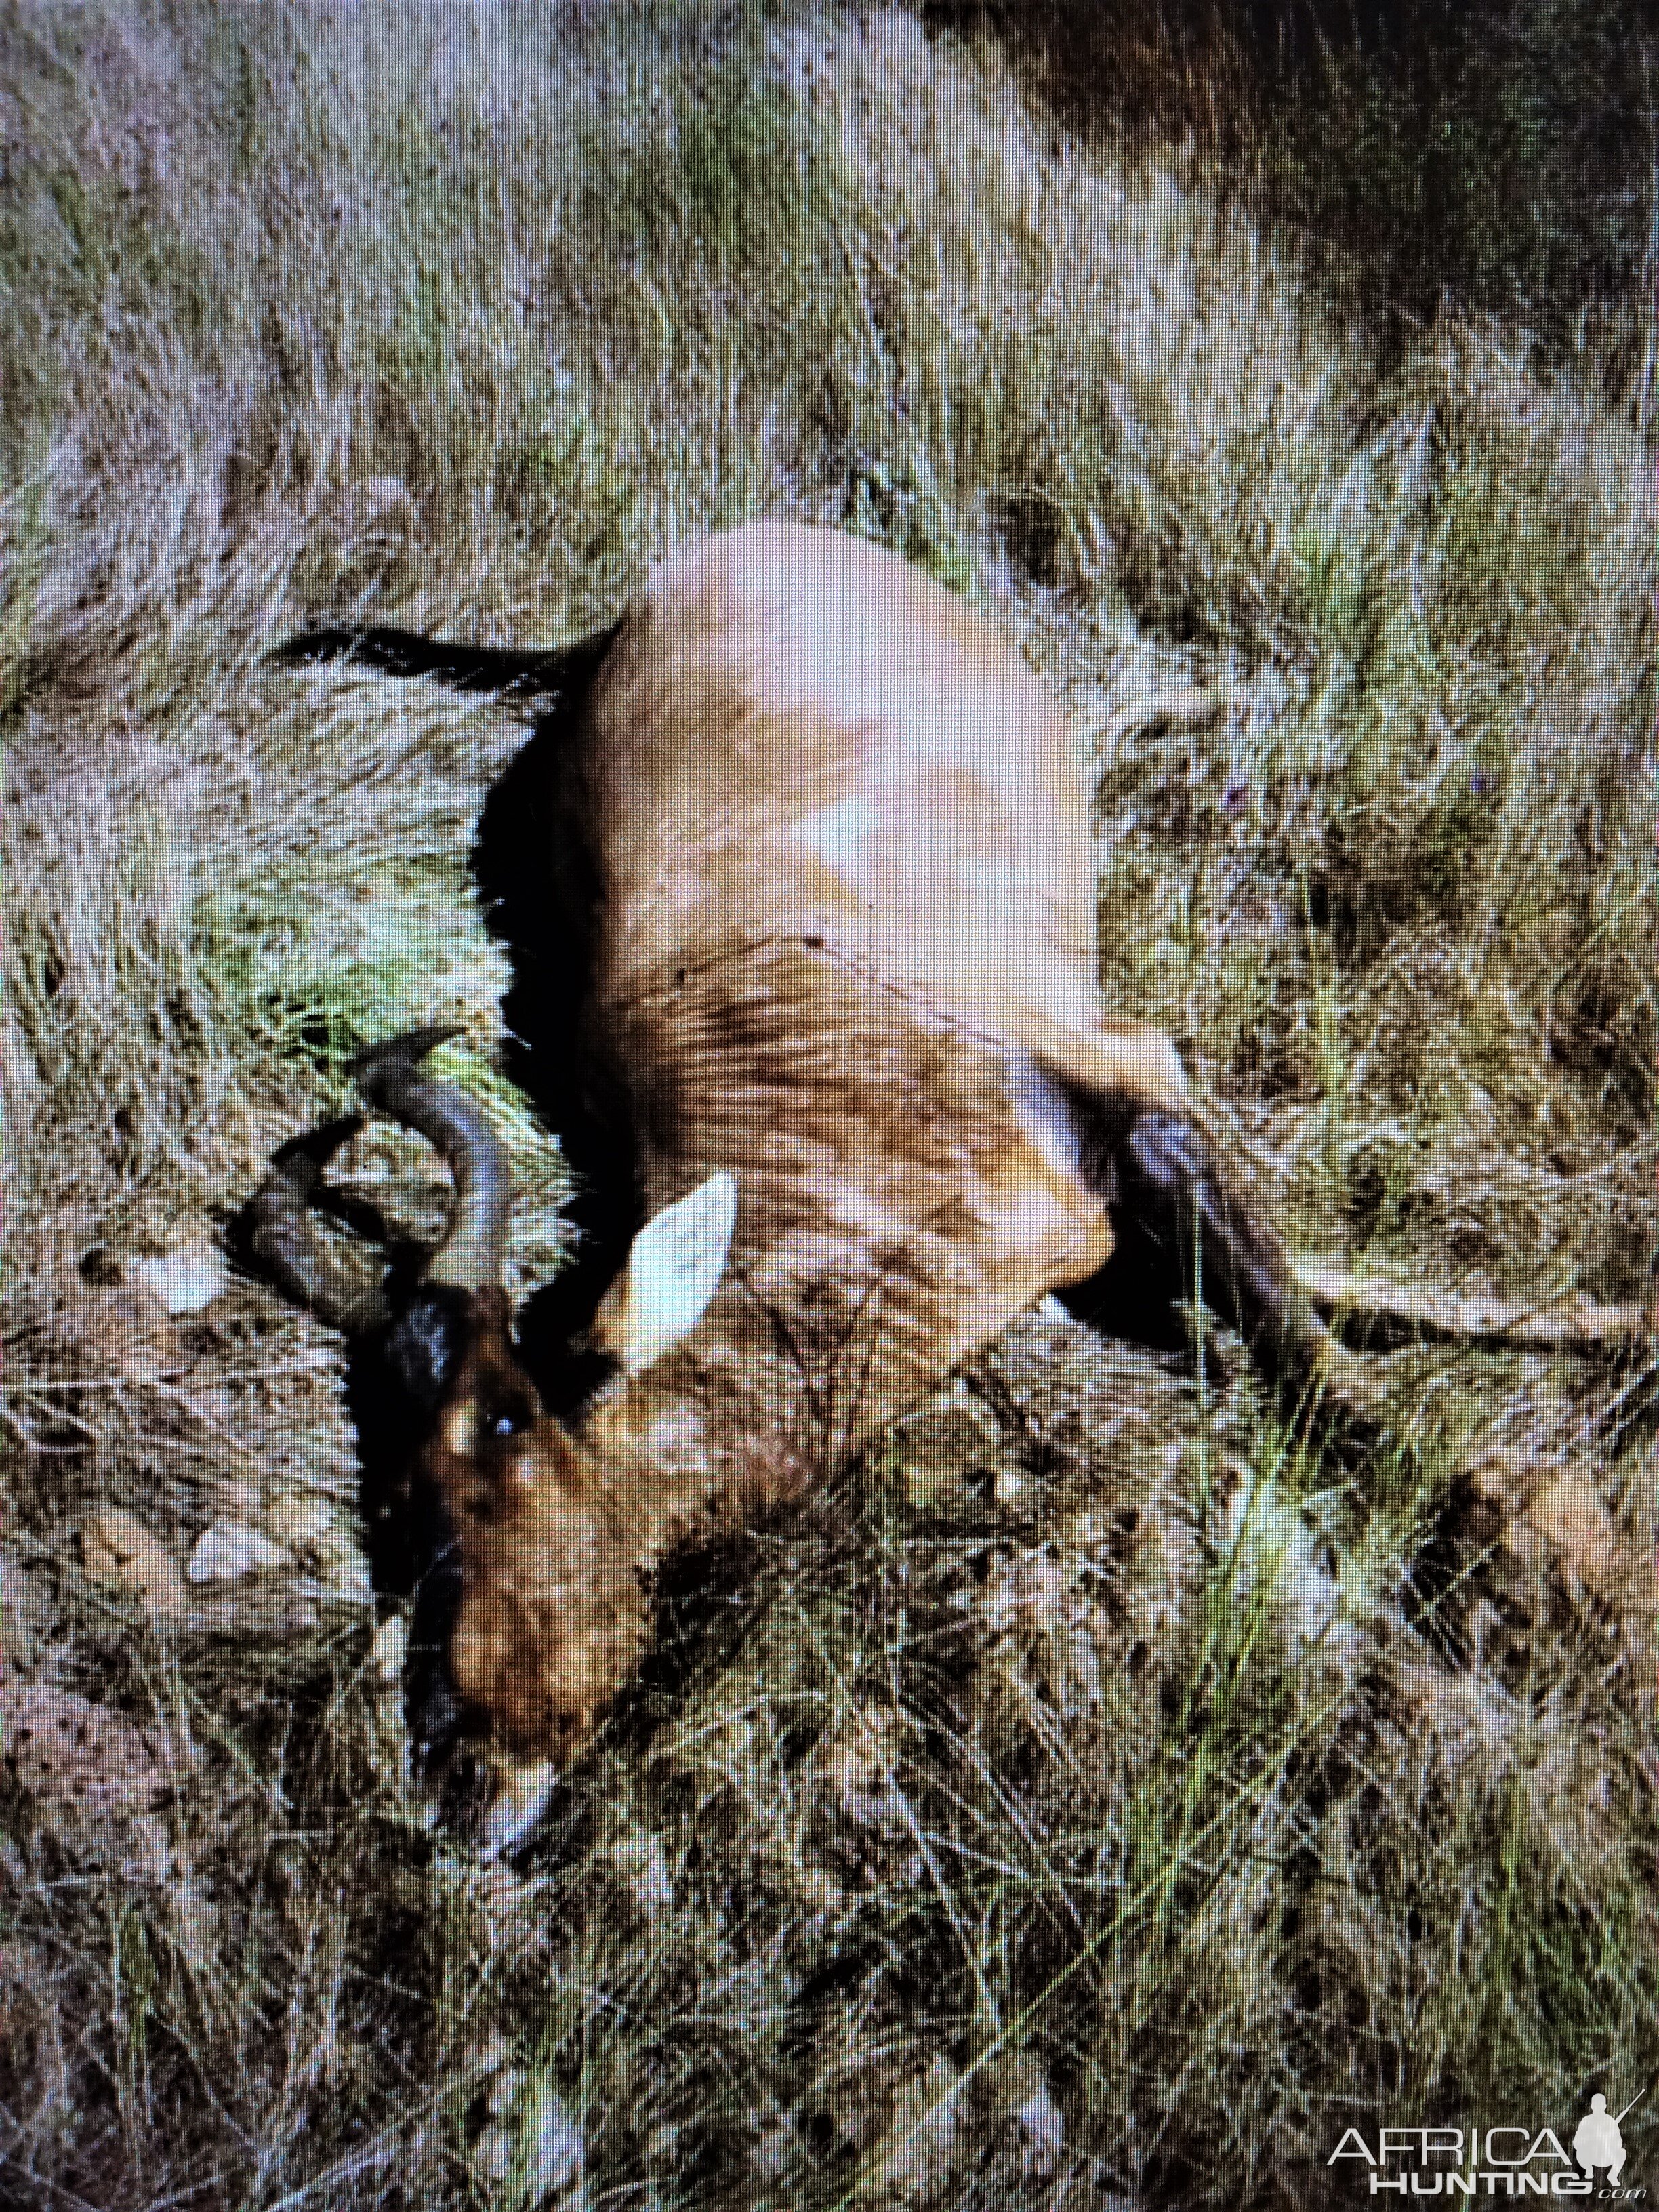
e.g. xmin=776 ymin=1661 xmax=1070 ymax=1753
xmin=924 ymin=0 xmax=1659 ymax=367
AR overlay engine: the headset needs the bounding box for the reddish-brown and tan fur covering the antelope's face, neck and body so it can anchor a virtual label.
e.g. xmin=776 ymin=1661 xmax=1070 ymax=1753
xmin=270 ymin=525 xmax=1327 ymax=1796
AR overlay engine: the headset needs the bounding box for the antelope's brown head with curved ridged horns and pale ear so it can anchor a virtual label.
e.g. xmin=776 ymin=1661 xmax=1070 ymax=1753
xmin=250 ymin=1029 xmax=735 ymax=1851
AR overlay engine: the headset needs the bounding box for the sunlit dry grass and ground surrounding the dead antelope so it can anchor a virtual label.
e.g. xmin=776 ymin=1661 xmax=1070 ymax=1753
xmin=0 ymin=0 xmax=1659 ymax=2212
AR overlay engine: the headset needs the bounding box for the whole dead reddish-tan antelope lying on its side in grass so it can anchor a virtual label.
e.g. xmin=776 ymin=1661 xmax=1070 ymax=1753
xmin=254 ymin=525 xmax=1353 ymax=1843
